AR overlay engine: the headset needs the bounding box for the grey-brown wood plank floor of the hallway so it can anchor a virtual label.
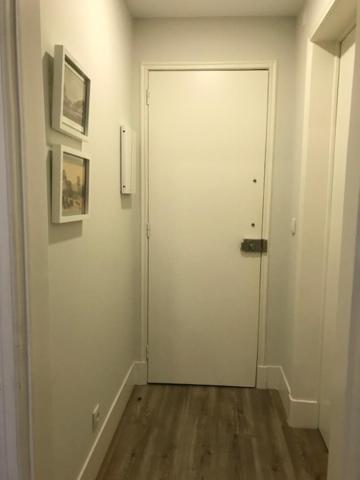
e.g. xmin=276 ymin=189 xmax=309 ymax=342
xmin=98 ymin=385 xmax=327 ymax=480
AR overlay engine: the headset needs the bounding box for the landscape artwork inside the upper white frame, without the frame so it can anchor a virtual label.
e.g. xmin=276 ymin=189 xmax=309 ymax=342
xmin=63 ymin=62 xmax=87 ymax=132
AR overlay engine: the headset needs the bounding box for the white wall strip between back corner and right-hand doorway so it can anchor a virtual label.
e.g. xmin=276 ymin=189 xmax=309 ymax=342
xmin=286 ymin=0 xmax=344 ymax=402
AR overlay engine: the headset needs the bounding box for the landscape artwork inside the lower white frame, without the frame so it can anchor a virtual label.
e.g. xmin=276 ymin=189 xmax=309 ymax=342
xmin=62 ymin=153 xmax=87 ymax=216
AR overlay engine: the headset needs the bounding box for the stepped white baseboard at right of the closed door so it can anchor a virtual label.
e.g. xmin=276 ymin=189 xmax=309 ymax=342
xmin=257 ymin=365 xmax=319 ymax=428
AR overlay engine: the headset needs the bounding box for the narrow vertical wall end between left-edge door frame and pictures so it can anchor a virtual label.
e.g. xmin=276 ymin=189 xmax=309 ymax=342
xmin=17 ymin=0 xmax=52 ymax=480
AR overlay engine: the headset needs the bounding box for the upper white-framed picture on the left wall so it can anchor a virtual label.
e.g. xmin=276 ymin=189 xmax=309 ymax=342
xmin=52 ymin=45 xmax=90 ymax=140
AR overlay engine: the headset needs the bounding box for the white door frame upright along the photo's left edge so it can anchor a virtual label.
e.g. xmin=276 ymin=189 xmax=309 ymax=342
xmin=0 ymin=0 xmax=32 ymax=480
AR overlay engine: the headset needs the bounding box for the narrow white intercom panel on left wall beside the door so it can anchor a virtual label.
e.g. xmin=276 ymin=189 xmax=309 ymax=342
xmin=120 ymin=125 xmax=136 ymax=195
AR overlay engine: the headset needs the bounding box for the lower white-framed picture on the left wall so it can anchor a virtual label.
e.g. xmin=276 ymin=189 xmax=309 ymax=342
xmin=52 ymin=145 xmax=90 ymax=223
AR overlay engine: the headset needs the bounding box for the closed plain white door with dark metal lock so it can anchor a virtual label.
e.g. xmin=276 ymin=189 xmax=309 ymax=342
xmin=149 ymin=70 xmax=269 ymax=386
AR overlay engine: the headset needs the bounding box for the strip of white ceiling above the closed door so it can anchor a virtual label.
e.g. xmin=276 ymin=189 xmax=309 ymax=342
xmin=127 ymin=0 xmax=303 ymax=17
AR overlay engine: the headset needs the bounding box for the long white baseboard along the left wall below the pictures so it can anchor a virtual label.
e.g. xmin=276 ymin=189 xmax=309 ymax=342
xmin=77 ymin=362 xmax=147 ymax=480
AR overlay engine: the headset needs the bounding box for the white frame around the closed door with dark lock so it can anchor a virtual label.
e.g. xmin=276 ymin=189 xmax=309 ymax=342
xmin=140 ymin=60 xmax=277 ymax=387
